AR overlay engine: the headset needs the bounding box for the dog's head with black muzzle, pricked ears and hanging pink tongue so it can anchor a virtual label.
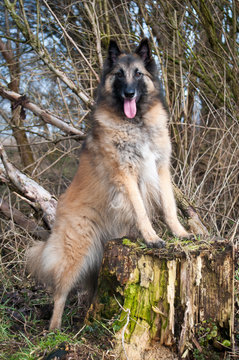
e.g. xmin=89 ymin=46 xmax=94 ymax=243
xmin=102 ymin=39 xmax=158 ymax=119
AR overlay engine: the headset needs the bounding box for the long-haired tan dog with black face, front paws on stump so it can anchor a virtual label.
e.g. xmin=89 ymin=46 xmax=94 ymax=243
xmin=27 ymin=39 xmax=189 ymax=329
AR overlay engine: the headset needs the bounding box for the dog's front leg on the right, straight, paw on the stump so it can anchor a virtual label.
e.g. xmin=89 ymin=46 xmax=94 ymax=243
xmin=158 ymin=166 xmax=190 ymax=237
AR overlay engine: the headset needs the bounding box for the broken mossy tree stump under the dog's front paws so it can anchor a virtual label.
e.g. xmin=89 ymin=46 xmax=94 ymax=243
xmin=97 ymin=239 xmax=234 ymax=360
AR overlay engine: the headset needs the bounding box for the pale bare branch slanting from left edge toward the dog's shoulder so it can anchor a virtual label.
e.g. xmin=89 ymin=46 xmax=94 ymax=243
xmin=0 ymin=85 xmax=85 ymax=140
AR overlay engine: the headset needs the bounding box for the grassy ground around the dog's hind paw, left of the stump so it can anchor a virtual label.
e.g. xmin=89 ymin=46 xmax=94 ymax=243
xmin=0 ymin=274 xmax=115 ymax=360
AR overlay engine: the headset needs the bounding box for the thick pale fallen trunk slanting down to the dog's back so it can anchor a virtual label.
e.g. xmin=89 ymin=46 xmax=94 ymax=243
xmin=0 ymin=146 xmax=57 ymax=228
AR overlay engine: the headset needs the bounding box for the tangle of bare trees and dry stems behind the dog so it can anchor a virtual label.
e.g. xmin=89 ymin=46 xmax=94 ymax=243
xmin=0 ymin=0 xmax=239 ymax=360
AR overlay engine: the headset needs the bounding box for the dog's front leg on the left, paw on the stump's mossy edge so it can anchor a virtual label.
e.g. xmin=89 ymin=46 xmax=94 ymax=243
xmin=123 ymin=175 xmax=165 ymax=248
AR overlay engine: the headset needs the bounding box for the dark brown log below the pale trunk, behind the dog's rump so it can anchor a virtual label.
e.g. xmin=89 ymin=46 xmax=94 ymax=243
xmin=0 ymin=198 xmax=49 ymax=240
